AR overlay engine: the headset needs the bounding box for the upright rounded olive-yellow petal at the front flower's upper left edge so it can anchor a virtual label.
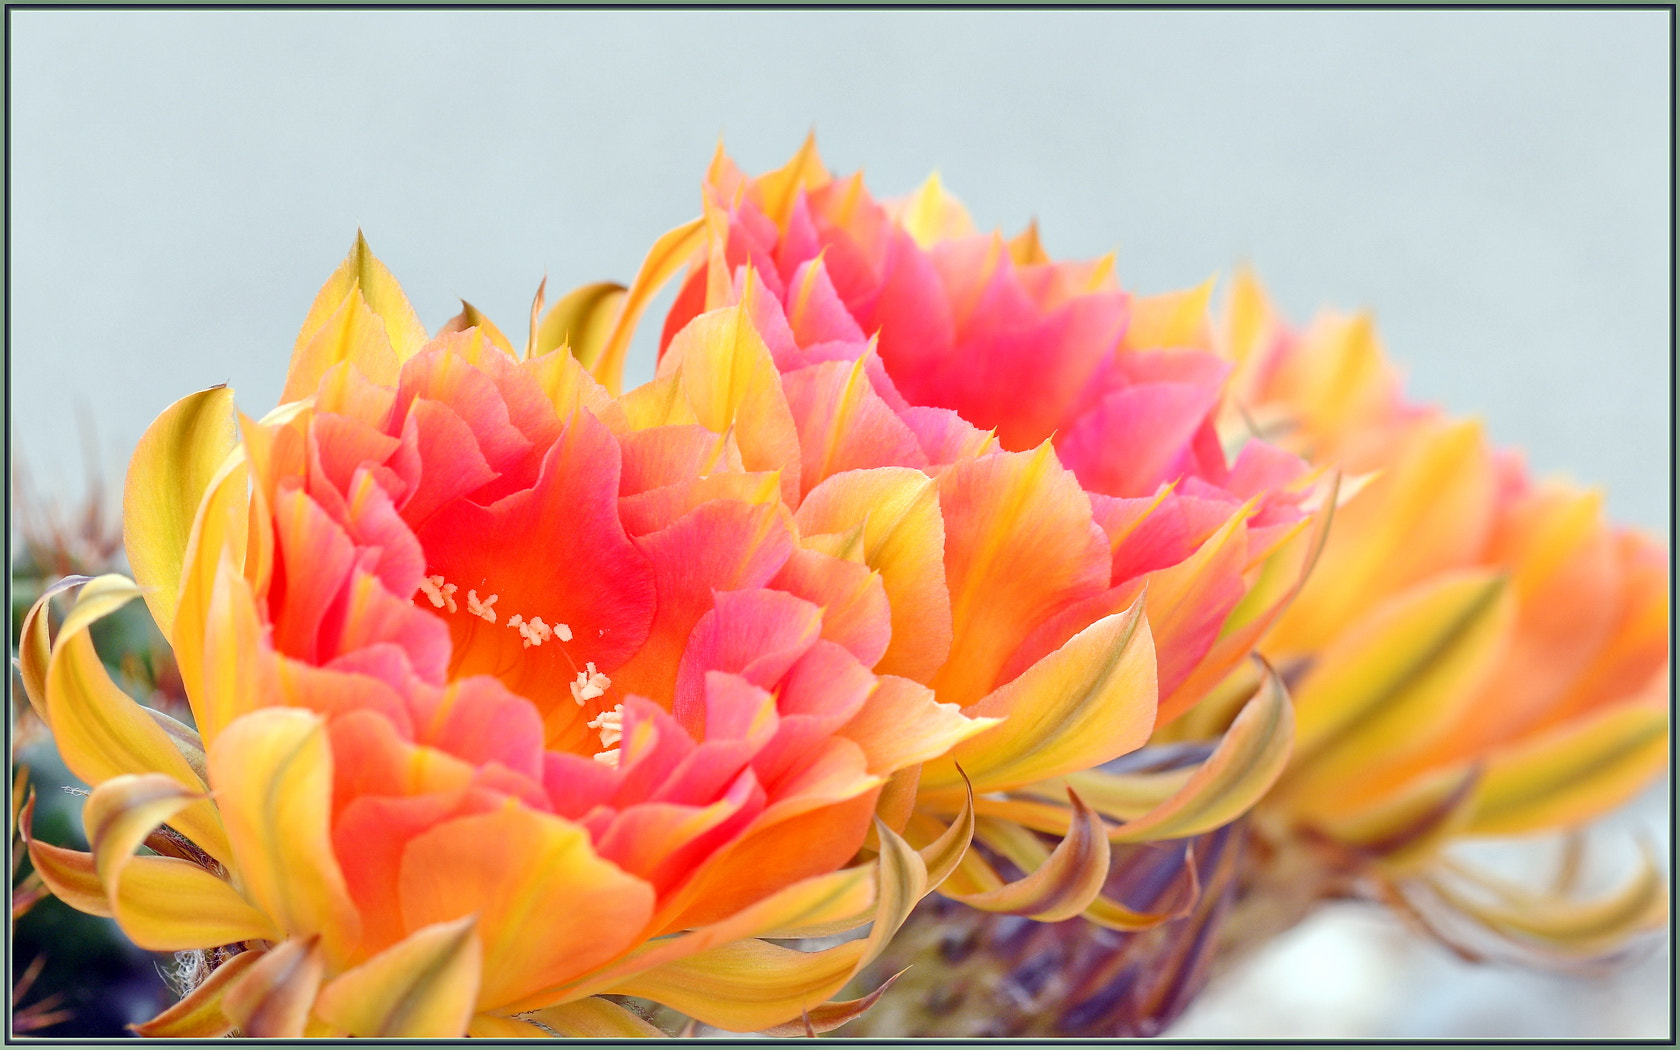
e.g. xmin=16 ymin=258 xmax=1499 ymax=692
xmin=123 ymin=386 xmax=239 ymax=637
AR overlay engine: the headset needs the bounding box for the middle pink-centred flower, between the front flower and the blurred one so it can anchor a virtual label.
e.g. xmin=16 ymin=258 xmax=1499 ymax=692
xmin=591 ymin=141 xmax=1324 ymax=947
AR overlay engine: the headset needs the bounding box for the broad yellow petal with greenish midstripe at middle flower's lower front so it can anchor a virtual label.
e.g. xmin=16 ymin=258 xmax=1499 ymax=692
xmin=922 ymin=600 xmax=1156 ymax=793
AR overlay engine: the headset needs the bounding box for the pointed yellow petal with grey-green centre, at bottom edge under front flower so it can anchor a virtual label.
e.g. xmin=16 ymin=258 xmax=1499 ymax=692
xmin=314 ymin=916 xmax=484 ymax=1038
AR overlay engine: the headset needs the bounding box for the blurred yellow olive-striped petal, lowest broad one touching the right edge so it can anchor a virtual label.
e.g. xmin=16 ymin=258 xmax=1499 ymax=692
xmin=1468 ymin=702 xmax=1668 ymax=835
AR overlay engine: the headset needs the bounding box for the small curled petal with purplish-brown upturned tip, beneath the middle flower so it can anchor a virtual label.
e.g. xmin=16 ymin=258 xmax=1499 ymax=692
xmin=951 ymin=791 xmax=1109 ymax=922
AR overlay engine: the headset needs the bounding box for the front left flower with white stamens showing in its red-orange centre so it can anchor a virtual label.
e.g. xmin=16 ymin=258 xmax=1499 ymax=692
xmin=20 ymin=239 xmax=991 ymax=1037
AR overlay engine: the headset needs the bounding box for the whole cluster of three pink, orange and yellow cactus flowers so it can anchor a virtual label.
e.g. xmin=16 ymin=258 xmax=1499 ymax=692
xmin=17 ymin=141 xmax=1668 ymax=1038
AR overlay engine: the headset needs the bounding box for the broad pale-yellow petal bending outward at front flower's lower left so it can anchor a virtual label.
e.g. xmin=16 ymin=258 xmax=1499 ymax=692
xmin=210 ymin=707 xmax=360 ymax=959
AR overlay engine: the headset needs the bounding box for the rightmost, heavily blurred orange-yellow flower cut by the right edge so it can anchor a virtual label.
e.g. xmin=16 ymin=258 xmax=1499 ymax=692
xmin=1203 ymin=274 xmax=1670 ymax=956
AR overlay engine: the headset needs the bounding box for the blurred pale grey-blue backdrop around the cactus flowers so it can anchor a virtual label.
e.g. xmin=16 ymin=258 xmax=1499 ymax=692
xmin=7 ymin=8 xmax=1673 ymax=1038
